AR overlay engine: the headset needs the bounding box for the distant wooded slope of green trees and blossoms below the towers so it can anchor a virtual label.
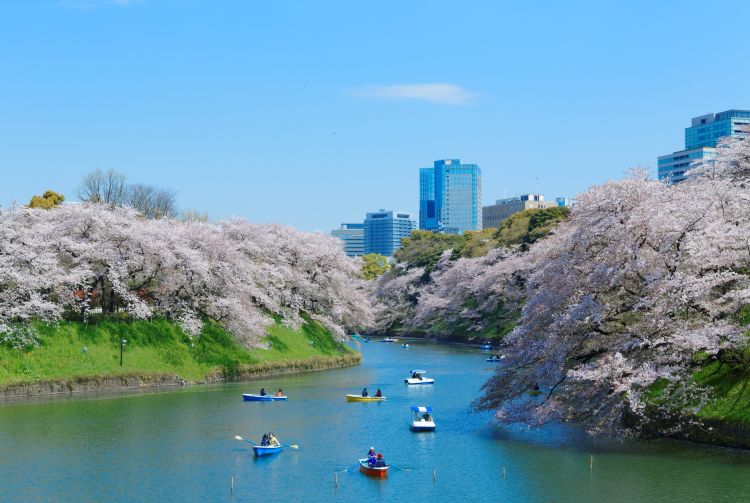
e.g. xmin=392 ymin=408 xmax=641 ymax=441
xmin=371 ymin=208 xmax=570 ymax=342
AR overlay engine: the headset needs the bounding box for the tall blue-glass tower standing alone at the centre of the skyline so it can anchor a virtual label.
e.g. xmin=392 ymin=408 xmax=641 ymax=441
xmin=419 ymin=159 xmax=482 ymax=234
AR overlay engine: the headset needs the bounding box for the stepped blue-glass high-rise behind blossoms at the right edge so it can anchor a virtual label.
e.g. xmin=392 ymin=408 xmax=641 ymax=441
xmin=657 ymin=110 xmax=750 ymax=183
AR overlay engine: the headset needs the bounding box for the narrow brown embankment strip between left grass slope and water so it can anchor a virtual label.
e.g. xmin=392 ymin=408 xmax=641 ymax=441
xmin=0 ymin=353 xmax=362 ymax=399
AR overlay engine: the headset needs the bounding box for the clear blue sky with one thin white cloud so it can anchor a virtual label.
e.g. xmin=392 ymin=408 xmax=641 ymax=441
xmin=0 ymin=0 xmax=750 ymax=231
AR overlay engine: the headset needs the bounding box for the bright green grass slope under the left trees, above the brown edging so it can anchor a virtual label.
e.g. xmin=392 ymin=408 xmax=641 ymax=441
xmin=0 ymin=319 xmax=351 ymax=388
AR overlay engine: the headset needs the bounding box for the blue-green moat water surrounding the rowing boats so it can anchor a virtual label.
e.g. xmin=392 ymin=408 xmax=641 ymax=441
xmin=0 ymin=343 xmax=750 ymax=502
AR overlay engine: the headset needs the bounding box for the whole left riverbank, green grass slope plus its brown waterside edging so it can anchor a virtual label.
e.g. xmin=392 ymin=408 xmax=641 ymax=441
xmin=0 ymin=319 xmax=361 ymax=398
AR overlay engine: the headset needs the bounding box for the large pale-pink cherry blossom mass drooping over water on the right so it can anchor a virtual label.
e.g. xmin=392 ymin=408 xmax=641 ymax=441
xmin=478 ymin=139 xmax=750 ymax=434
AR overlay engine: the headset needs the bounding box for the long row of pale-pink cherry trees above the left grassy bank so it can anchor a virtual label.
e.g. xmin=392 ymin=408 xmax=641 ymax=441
xmin=0 ymin=203 xmax=371 ymax=346
